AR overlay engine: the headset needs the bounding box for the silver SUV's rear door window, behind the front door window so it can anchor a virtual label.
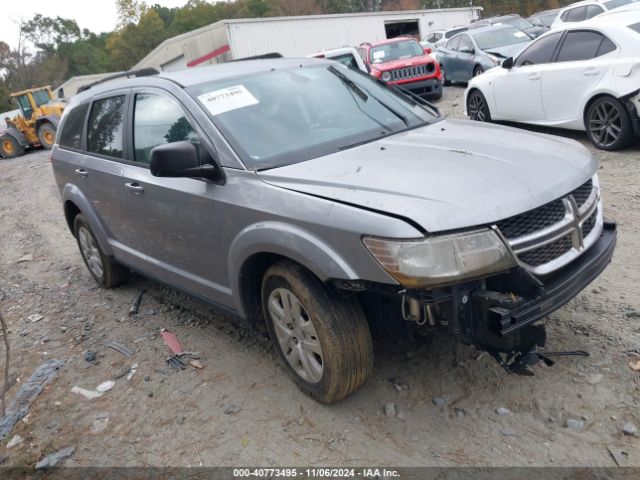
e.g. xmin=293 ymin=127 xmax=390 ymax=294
xmin=87 ymin=95 xmax=126 ymax=158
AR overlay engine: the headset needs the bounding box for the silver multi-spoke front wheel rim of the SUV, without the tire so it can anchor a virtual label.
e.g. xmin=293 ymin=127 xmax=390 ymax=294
xmin=267 ymin=288 xmax=324 ymax=383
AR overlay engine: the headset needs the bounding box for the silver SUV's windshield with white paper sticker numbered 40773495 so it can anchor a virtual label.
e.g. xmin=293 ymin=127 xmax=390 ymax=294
xmin=187 ymin=64 xmax=440 ymax=170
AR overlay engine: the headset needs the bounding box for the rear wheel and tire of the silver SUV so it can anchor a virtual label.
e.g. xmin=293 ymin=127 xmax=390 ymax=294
xmin=73 ymin=213 xmax=129 ymax=288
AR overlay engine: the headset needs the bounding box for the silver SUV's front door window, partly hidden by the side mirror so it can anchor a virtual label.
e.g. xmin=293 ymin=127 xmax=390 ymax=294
xmin=133 ymin=93 xmax=198 ymax=165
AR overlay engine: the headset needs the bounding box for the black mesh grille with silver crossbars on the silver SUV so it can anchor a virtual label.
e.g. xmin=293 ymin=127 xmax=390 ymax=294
xmin=495 ymin=177 xmax=603 ymax=275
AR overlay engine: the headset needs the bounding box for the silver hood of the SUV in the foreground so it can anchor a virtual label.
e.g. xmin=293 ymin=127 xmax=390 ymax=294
xmin=258 ymin=120 xmax=597 ymax=232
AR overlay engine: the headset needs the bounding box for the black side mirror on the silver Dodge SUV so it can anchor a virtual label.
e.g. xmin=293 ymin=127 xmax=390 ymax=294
xmin=149 ymin=142 xmax=219 ymax=180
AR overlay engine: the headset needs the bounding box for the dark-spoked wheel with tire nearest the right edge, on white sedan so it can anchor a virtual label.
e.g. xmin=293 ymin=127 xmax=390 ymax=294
xmin=584 ymin=96 xmax=634 ymax=151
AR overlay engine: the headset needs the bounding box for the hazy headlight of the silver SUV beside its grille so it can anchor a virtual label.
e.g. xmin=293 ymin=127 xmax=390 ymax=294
xmin=362 ymin=230 xmax=516 ymax=288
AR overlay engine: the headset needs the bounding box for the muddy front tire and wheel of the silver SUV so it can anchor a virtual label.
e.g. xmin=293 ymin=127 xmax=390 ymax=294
xmin=262 ymin=260 xmax=373 ymax=403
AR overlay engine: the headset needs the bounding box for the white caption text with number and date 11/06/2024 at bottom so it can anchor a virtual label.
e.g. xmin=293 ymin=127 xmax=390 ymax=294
xmin=233 ymin=468 xmax=400 ymax=479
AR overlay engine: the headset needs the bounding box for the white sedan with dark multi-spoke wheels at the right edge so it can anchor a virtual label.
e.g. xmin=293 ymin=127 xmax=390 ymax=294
xmin=464 ymin=10 xmax=640 ymax=150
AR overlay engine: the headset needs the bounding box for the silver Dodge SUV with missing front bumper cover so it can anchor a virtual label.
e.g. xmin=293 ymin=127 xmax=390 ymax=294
xmin=52 ymin=59 xmax=616 ymax=402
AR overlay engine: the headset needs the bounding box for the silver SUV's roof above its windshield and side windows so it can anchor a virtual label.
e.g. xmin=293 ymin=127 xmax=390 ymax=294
xmin=72 ymin=58 xmax=334 ymax=104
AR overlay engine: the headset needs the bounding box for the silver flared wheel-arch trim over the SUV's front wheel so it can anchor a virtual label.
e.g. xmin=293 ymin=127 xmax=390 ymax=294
xmin=227 ymin=222 xmax=358 ymax=316
